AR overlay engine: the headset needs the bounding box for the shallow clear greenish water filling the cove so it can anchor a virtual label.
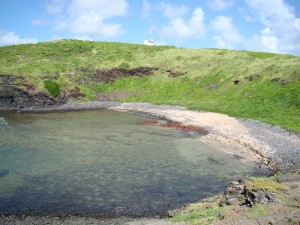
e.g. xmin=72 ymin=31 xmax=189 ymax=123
xmin=0 ymin=110 xmax=259 ymax=216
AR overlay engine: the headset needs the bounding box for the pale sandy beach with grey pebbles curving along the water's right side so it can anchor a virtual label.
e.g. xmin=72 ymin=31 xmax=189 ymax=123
xmin=109 ymin=103 xmax=300 ymax=172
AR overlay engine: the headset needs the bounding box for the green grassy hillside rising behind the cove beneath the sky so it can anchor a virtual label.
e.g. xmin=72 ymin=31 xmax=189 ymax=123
xmin=0 ymin=40 xmax=300 ymax=131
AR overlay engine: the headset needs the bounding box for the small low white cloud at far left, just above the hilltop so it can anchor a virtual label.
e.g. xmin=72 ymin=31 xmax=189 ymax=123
xmin=0 ymin=30 xmax=38 ymax=45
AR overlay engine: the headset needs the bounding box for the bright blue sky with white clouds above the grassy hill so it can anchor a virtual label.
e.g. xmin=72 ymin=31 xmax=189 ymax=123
xmin=0 ymin=0 xmax=300 ymax=55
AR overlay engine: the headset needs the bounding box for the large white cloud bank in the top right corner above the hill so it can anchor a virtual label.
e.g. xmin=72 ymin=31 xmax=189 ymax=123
xmin=211 ymin=0 xmax=300 ymax=55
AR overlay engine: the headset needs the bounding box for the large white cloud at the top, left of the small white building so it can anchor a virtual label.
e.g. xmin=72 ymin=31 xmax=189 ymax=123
xmin=48 ymin=0 xmax=129 ymax=40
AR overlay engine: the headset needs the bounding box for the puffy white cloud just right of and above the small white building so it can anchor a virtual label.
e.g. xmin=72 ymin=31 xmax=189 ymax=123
xmin=162 ymin=7 xmax=206 ymax=41
